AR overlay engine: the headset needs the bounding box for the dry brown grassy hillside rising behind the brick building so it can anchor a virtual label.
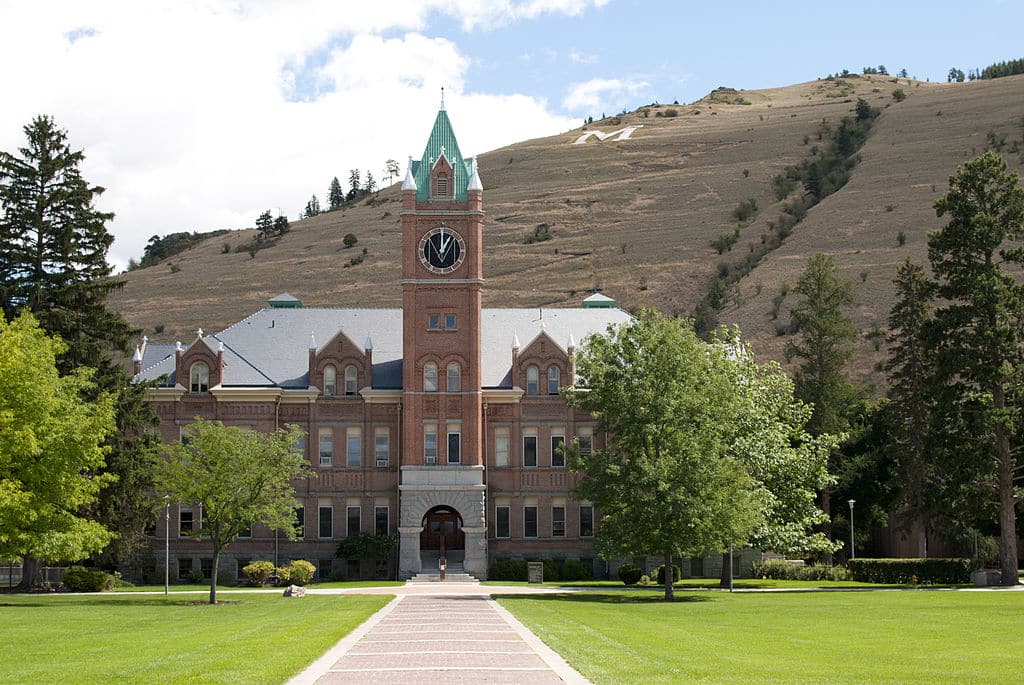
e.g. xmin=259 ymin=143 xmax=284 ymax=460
xmin=113 ymin=76 xmax=1024 ymax=383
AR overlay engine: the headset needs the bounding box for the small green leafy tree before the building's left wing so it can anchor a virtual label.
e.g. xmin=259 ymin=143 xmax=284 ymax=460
xmin=156 ymin=419 xmax=308 ymax=604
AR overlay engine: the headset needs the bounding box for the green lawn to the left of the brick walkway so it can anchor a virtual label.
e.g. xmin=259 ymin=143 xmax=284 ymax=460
xmin=0 ymin=593 xmax=391 ymax=685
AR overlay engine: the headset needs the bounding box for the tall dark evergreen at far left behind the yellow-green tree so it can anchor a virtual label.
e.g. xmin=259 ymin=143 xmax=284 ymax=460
xmin=0 ymin=116 xmax=157 ymax=566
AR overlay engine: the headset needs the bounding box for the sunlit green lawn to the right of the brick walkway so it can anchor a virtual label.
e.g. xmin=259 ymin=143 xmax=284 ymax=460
xmin=499 ymin=590 xmax=1024 ymax=683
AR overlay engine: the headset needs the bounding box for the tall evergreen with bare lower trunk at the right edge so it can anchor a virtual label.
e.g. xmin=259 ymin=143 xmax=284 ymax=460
xmin=928 ymin=152 xmax=1024 ymax=585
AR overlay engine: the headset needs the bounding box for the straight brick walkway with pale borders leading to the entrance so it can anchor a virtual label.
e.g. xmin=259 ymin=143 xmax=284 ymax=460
xmin=290 ymin=584 xmax=588 ymax=685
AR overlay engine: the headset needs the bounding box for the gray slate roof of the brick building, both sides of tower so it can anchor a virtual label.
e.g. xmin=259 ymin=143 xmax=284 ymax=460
xmin=135 ymin=308 xmax=630 ymax=389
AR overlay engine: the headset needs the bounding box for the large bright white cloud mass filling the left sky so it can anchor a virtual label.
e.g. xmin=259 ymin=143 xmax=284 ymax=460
xmin=0 ymin=0 xmax=585 ymax=266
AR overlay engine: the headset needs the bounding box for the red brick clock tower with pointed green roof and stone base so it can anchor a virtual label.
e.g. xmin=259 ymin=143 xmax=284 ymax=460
xmin=399 ymin=102 xmax=487 ymax=576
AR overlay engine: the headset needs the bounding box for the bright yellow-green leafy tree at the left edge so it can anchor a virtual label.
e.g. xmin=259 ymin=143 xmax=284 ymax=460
xmin=0 ymin=312 xmax=115 ymax=587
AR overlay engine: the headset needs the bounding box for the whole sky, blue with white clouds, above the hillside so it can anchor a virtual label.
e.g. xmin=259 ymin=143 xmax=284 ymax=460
xmin=0 ymin=0 xmax=1024 ymax=266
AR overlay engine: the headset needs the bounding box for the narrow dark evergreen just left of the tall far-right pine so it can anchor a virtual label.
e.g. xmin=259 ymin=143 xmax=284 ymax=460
xmin=887 ymin=259 xmax=934 ymax=557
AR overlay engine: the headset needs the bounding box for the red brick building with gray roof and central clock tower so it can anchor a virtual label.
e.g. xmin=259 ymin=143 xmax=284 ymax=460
xmin=135 ymin=105 xmax=629 ymax=579
